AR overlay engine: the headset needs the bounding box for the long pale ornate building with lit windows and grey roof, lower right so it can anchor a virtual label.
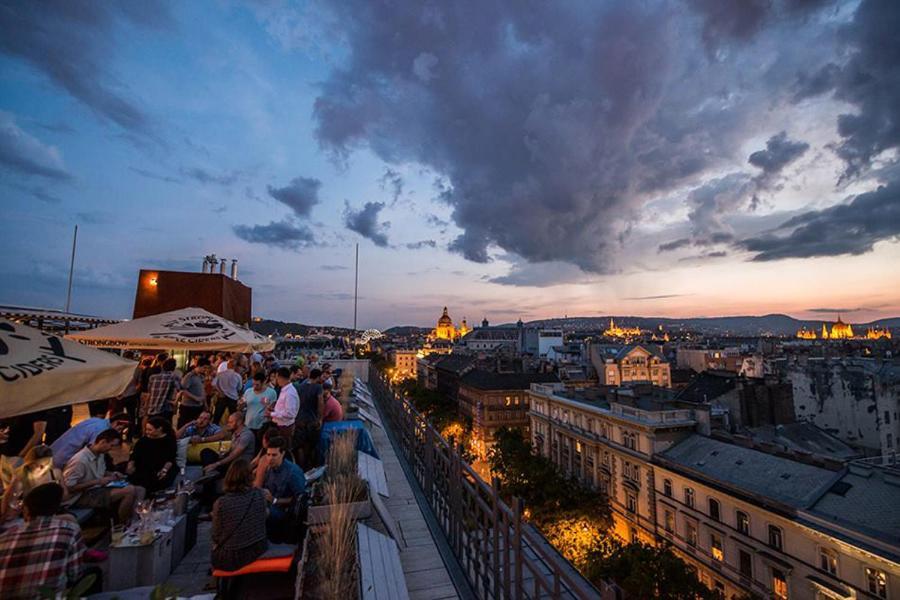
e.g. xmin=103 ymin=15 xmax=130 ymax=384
xmin=529 ymin=385 xmax=900 ymax=600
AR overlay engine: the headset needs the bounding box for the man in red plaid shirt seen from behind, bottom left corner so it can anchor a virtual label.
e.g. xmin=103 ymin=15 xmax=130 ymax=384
xmin=0 ymin=483 xmax=102 ymax=599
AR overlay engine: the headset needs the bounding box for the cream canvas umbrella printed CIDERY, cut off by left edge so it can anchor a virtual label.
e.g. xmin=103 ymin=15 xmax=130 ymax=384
xmin=0 ymin=319 xmax=137 ymax=419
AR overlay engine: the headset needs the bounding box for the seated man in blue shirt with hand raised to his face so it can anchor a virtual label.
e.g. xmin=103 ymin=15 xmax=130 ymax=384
xmin=254 ymin=436 xmax=306 ymax=543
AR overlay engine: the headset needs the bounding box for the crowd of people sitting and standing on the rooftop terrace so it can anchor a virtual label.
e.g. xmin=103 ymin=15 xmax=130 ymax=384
xmin=0 ymin=353 xmax=343 ymax=598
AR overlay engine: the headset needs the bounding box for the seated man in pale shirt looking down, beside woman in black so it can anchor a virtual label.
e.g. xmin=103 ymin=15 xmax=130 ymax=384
xmin=63 ymin=429 xmax=144 ymax=523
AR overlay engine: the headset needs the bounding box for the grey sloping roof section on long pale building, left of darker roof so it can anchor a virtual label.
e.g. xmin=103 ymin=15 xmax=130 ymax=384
xmin=657 ymin=434 xmax=839 ymax=508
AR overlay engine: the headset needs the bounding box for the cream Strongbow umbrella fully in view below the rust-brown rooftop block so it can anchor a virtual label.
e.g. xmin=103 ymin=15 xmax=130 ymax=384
xmin=66 ymin=308 xmax=275 ymax=352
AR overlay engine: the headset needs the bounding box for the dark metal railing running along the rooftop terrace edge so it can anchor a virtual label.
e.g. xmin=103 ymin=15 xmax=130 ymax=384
xmin=369 ymin=368 xmax=607 ymax=599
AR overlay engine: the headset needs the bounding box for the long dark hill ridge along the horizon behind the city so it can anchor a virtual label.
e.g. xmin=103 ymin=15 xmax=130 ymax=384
xmin=527 ymin=314 xmax=900 ymax=336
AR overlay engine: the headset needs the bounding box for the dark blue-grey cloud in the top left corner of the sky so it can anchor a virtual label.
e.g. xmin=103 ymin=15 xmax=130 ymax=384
xmin=0 ymin=0 xmax=170 ymax=138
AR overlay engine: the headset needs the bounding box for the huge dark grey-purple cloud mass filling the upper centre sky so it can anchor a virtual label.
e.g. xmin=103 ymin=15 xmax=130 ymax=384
xmin=314 ymin=0 xmax=836 ymax=273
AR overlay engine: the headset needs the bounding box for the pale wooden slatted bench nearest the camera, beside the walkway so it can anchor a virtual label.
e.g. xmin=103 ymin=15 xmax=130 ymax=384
xmin=356 ymin=523 xmax=409 ymax=600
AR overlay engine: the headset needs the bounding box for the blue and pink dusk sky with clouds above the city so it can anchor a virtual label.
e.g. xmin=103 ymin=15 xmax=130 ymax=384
xmin=0 ymin=0 xmax=900 ymax=328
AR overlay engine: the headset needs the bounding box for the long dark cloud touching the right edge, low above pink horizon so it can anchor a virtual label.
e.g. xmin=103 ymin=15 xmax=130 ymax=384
xmin=740 ymin=173 xmax=900 ymax=261
